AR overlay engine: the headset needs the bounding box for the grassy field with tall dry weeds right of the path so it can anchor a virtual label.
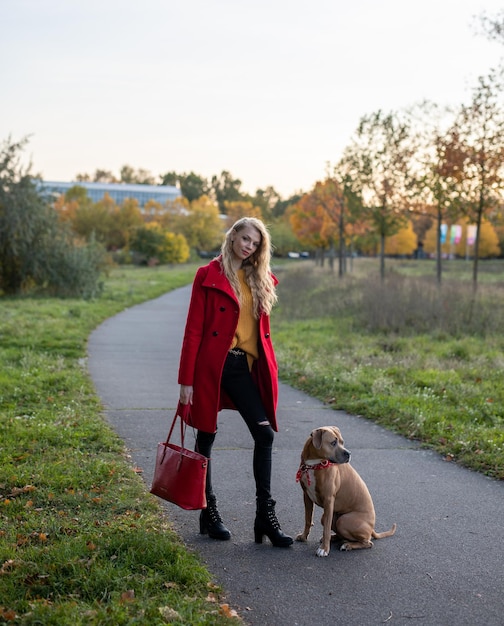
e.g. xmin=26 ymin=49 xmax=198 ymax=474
xmin=273 ymin=260 xmax=504 ymax=480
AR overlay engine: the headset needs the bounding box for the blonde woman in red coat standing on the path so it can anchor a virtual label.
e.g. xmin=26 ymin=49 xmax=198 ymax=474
xmin=179 ymin=217 xmax=292 ymax=547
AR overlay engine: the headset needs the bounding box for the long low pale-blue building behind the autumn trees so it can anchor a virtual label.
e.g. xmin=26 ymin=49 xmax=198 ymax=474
xmin=37 ymin=180 xmax=182 ymax=208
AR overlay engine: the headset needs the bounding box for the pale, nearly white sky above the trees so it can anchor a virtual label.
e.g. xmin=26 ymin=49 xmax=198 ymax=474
xmin=0 ymin=0 xmax=504 ymax=198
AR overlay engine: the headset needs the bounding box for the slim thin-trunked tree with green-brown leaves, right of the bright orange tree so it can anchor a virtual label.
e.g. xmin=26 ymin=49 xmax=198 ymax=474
xmin=339 ymin=111 xmax=414 ymax=280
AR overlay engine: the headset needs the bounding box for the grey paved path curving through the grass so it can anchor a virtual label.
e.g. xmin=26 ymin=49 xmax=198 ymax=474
xmin=89 ymin=287 xmax=504 ymax=626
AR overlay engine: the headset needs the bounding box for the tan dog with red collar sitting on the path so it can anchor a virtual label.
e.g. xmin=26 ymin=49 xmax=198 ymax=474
xmin=296 ymin=426 xmax=396 ymax=557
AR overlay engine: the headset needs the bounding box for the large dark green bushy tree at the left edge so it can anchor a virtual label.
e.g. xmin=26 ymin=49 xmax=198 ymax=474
xmin=0 ymin=138 xmax=104 ymax=297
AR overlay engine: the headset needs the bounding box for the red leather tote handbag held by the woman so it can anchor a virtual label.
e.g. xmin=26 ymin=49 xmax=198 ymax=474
xmin=150 ymin=404 xmax=208 ymax=510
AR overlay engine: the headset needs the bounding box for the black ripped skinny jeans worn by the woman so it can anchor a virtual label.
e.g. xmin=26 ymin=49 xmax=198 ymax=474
xmin=196 ymin=353 xmax=274 ymax=502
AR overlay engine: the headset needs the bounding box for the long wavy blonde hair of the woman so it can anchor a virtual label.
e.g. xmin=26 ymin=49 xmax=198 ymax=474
xmin=221 ymin=217 xmax=277 ymax=319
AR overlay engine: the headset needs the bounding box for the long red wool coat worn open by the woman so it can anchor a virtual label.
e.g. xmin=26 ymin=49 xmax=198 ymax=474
xmin=178 ymin=259 xmax=278 ymax=433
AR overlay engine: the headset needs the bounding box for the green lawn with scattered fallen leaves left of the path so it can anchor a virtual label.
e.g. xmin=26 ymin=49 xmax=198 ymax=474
xmin=0 ymin=266 xmax=238 ymax=626
